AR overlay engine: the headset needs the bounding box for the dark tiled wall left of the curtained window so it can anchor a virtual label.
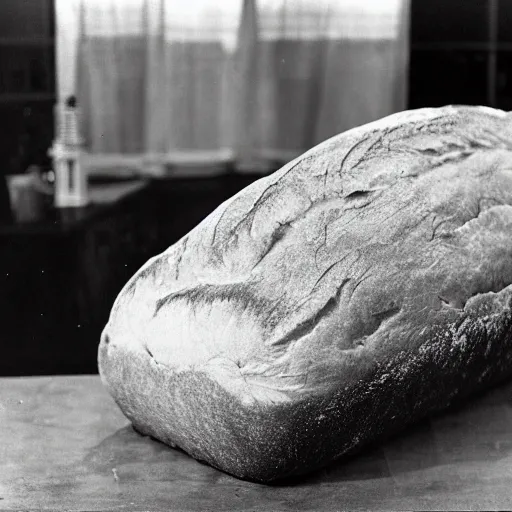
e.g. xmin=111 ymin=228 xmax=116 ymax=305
xmin=0 ymin=0 xmax=55 ymax=174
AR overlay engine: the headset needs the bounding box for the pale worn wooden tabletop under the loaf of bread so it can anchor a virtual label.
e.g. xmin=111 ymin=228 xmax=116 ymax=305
xmin=0 ymin=376 xmax=512 ymax=511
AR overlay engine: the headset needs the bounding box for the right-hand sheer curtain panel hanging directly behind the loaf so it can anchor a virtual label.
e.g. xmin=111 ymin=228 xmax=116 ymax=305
xmin=235 ymin=0 xmax=409 ymax=172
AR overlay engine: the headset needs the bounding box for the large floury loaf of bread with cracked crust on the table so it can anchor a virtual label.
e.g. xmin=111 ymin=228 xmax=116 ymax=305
xmin=99 ymin=106 xmax=512 ymax=482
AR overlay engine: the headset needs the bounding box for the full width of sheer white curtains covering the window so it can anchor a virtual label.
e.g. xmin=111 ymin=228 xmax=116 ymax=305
xmin=56 ymin=0 xmax=409 ymax=175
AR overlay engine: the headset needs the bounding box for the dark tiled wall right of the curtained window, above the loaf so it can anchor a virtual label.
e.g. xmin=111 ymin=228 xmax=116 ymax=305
xmin=409 ymin=0 xmax=512 ymax=110
